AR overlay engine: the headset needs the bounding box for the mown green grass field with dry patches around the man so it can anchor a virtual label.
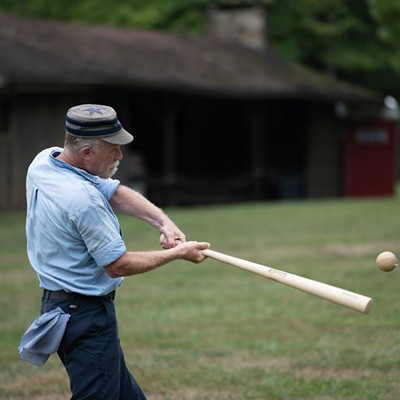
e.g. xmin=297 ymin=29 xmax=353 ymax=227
xmin=0 ymin=198 xmax=400 ymax=400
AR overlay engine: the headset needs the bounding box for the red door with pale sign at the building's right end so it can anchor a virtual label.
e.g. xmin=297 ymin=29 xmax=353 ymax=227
xmin=346 ymin=121 xmax=396 ymax=197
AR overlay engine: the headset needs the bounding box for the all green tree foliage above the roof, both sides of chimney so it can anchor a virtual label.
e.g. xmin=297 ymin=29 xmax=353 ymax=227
xmin=0 ymin=0 xmax=400 ymax=97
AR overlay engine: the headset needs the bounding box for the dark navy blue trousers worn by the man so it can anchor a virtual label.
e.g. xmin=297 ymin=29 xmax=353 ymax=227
xmin=41 ymin=297 xmax=146 ymax=400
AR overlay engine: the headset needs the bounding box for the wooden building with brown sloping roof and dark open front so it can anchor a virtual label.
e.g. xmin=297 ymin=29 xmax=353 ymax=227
xmin=0 ymin=11 xmax=394 ymax=209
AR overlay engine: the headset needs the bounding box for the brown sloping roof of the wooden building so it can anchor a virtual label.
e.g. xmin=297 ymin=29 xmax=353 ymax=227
xmin=0 ymin=14 xmax=377 ymax=101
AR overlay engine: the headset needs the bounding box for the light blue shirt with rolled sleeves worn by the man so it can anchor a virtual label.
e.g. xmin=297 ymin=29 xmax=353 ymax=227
xmin=26 ymin=147 xmax=126 ymax=296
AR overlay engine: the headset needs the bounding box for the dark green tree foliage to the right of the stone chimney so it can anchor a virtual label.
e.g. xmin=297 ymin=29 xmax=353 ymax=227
xmin=269 ymin=0 xmax=400 ymax=97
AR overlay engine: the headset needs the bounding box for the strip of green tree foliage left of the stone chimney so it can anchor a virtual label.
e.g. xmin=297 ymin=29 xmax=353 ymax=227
xmin=0 ymin=0 xmax=212 ymax=35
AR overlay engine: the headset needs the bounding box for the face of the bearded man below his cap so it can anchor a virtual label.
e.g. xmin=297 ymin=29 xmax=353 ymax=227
xmin=86 ymin=141 xmax=123 ymax=178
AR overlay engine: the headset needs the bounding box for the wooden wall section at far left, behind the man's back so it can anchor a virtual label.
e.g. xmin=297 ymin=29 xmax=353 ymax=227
xmin=0 ymin=92 xmax=89 ymax=209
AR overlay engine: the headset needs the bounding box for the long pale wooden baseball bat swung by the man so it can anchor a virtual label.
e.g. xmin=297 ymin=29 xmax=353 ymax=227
xmin=203 ymin=249 xmax=373 ymax=314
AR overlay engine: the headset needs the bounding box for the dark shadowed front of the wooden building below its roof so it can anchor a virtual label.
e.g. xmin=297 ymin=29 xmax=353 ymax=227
xmin=0 ymin=87 xmax=360 ymax=209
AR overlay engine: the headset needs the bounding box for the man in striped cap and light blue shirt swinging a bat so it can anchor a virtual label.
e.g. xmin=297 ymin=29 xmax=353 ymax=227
xmin=26 ymin=104 xmax=209 ymax=400
